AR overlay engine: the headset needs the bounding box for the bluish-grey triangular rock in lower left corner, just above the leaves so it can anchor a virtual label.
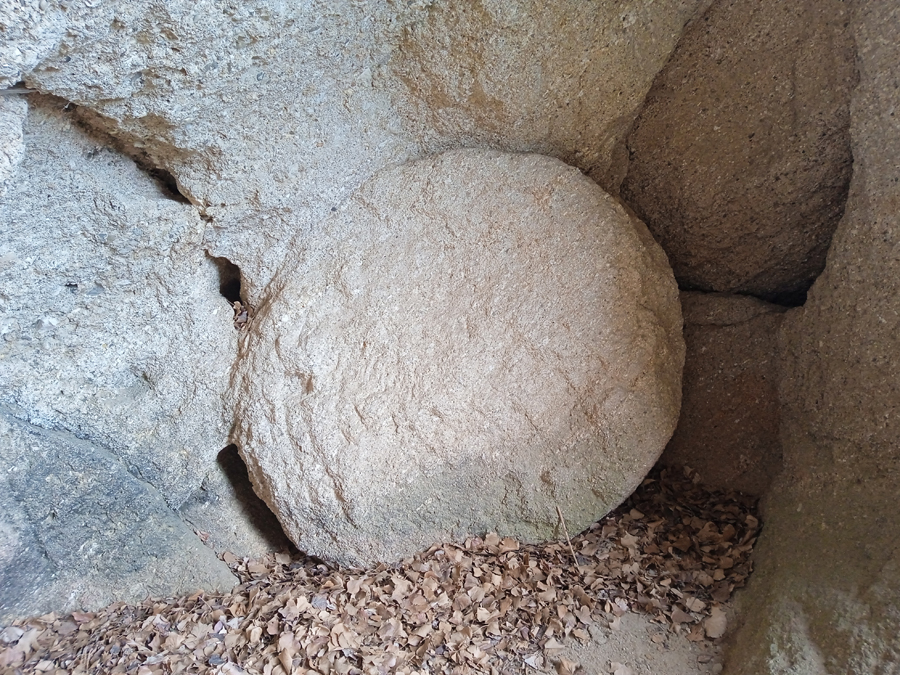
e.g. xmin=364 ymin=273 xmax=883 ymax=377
xmin=0 ymin=409 xmax=236 ymax=624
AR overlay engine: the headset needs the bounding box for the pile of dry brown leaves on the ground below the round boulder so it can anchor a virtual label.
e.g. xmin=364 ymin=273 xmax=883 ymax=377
xmin=0 ymin=471 xmax=758 ymax=675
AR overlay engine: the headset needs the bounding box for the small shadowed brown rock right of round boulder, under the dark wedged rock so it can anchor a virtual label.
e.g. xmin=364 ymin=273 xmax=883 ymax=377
xmin=660 ymin=292 xmax=785 ymax=495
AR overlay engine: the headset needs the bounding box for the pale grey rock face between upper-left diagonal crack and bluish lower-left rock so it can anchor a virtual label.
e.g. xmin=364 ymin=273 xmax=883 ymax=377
xmin=0 ymin=95 xmax=237 ymax=507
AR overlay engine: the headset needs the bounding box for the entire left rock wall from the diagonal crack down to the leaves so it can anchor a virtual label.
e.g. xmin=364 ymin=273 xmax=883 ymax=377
xmin=0 ymin=96 xmax=243 ymax=621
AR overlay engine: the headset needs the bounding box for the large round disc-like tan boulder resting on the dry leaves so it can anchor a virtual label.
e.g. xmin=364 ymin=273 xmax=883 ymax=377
xmin=235 ymin=151 xmax=684 ymax=564
